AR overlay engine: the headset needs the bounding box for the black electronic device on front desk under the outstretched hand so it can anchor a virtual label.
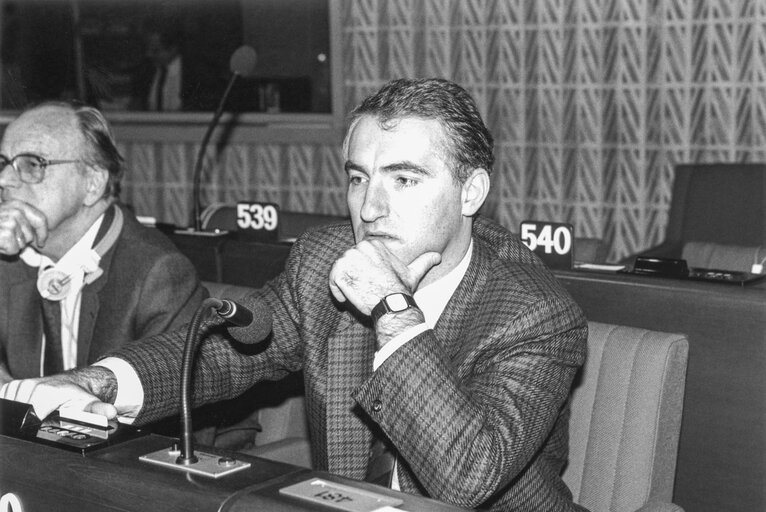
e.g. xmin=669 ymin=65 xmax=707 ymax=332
xmin=0 ymin=398 xmax=144 ymax=455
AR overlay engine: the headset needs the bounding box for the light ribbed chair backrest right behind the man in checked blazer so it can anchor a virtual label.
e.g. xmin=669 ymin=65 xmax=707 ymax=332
xmin=563 ymin=322 xmax=689 ymax=512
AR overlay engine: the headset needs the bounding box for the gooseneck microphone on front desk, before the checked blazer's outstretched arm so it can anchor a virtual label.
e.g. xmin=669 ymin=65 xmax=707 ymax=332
xmin=176 ymin=297 xmax=272 ymax=466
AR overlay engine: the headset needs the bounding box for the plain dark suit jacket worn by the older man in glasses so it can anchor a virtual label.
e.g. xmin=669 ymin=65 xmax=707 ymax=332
xmin=0 ymin=206 xmax=207 ymax=379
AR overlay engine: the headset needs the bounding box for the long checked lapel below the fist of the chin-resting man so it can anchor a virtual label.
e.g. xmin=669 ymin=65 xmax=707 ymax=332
xmin=326 ymin=313 xmax=375 ymax=479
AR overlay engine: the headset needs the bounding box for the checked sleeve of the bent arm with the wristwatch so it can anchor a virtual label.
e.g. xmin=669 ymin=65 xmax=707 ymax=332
xmin=355 ymin=297 xmax=587 ymax=507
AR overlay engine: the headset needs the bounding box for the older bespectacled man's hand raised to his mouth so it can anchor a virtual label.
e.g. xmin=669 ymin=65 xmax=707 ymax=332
xmin=0 ymin=199 xmax=48 ymax=255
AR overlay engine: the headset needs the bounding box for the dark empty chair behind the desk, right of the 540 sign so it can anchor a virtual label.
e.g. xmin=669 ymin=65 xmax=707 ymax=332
xmin=626 ymin=163 xmax=766 ymax=262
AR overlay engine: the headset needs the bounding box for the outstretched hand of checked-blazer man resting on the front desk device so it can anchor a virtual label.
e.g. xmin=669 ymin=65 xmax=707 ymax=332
xmin=0 ymin=366 xmax=117 ymax=419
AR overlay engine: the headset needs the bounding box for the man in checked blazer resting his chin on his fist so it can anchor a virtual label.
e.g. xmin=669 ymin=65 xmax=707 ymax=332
xmin=0 ymin=79 xmax=587 ymax=511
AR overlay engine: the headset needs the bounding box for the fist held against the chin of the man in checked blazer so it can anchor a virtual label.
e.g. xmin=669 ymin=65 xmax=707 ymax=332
xmin=330 ymin=240 xmax=441 ymax=315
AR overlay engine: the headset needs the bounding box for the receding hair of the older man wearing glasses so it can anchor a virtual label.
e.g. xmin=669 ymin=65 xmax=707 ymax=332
xmin=32 ymin=101 xmax=125 ymax=198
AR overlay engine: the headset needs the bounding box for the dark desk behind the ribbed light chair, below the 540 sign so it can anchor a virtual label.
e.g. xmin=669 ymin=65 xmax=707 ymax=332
xmin=556 ymin=271 xmax=766 ymax=512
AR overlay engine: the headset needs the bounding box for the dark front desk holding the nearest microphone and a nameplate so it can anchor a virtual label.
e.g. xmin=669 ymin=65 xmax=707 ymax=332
xmin=0 ymin=435 xmax=465 ymax=512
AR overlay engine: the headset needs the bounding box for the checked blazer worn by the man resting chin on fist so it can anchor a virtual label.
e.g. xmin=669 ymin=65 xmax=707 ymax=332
xmin=115 ymin=214 xmax=587 ymax=511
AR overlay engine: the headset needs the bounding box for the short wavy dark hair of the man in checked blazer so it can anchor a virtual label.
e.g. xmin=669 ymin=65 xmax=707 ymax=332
xmin=344 ymin=78 xmax=495 ymax=183
